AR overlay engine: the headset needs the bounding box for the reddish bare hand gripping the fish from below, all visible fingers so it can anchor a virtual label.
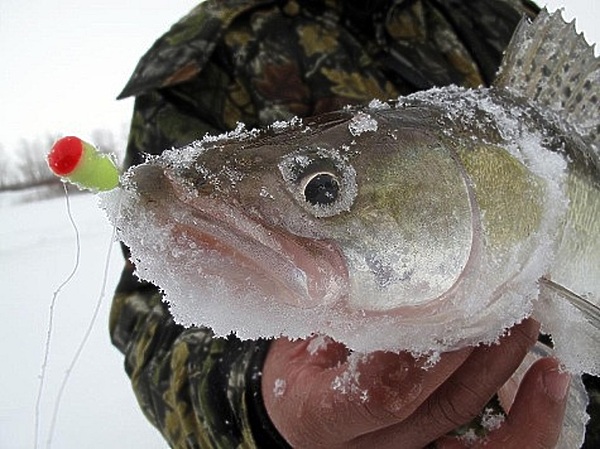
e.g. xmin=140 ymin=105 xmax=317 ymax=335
xmin=262 ymin=320 xmax=570 ymax=449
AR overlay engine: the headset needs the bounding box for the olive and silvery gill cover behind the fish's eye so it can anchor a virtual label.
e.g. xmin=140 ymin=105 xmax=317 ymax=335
xmin=340 ymin=142 xmax=474 ymax=311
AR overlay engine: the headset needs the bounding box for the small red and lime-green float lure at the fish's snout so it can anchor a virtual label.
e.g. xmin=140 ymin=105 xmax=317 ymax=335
xmin=47 ymin=136 xmax=119 ymax=192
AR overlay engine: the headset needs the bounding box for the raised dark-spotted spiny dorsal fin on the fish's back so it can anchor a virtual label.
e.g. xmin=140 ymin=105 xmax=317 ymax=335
xmin=494 ymin=9 xmax=600 ymax=152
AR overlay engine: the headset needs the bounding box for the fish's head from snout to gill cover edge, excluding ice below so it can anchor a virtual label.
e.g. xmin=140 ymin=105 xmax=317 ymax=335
xmin=128 ymin=111 xmax=479 ymax=315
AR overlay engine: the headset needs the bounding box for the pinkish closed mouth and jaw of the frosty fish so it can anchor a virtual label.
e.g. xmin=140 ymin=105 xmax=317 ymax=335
xmin=172 ymin=197 xmax=348 ymax=308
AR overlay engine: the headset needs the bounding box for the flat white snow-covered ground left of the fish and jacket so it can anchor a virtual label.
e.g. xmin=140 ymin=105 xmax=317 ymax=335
xmin=0 ymin=190 xmax=167 ymax=449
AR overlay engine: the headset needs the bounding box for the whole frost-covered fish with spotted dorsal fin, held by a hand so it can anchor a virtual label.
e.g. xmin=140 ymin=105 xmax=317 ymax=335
xmin=102 ymin=10 xmax=600 ymax=375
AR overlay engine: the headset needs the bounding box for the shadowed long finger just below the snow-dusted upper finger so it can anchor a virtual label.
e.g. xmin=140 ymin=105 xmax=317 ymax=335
xmin=346 ymin=320 xmax=539 ymax=448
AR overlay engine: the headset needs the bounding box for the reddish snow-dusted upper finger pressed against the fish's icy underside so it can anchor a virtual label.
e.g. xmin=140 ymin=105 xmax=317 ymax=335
xmin=263 ymin=334 xmax=472 ymax=446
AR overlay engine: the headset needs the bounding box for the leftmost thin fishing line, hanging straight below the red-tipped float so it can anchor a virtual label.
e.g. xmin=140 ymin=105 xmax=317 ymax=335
xmin=34 ymin=183 xmax=81 ymax=449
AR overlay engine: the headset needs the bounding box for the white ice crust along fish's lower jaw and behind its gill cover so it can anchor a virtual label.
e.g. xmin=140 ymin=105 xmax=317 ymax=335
xmin=99 ymin=83 xmax=592 ymax=367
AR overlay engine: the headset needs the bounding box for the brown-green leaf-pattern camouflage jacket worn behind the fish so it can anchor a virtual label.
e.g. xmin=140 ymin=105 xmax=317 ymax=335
xmin=110 ymin=0 xmax=591 ymax=448
